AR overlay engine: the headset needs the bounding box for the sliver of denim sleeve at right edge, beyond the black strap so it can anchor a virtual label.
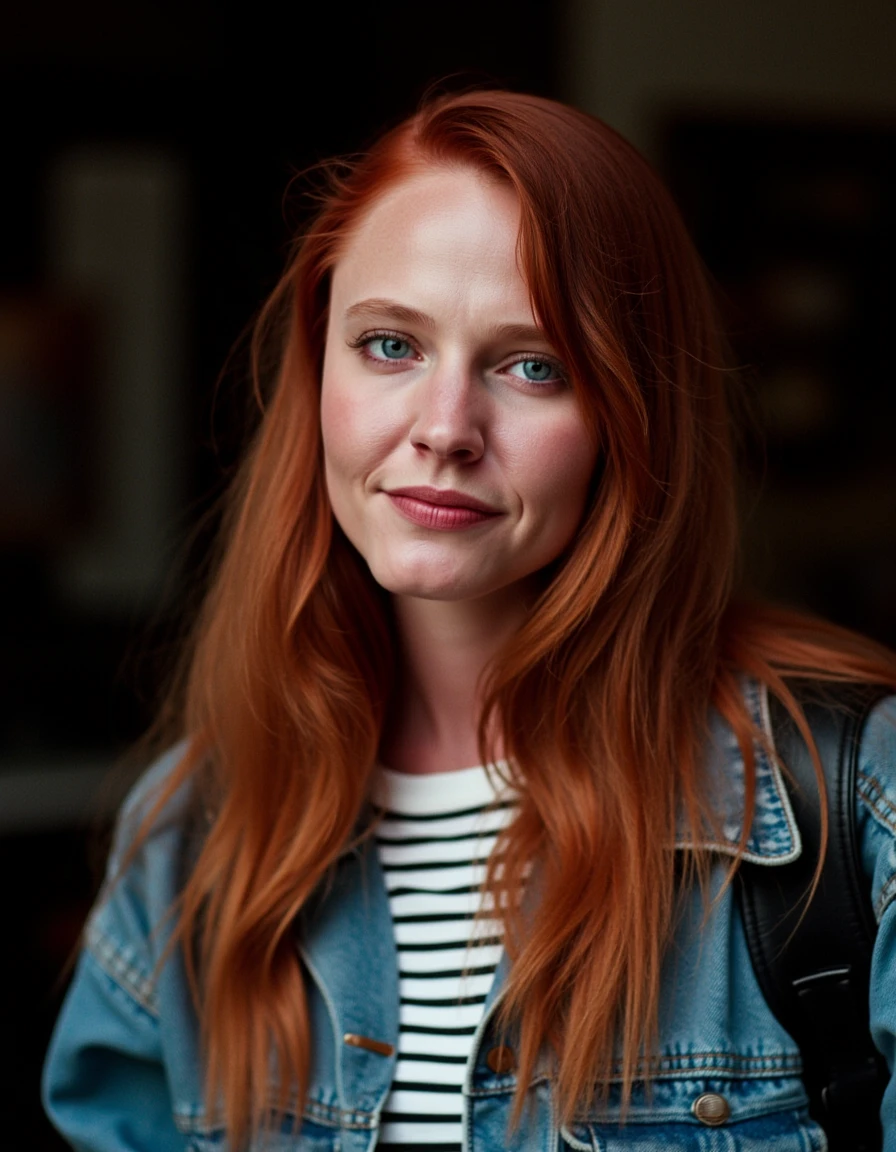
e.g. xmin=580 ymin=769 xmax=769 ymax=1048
xmin=857 ymin=697 xmax=896 ymax=1152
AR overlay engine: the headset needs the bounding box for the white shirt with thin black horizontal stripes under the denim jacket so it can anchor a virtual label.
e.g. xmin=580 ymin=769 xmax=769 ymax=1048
xmin=373 ymin=767 xmax=512 ymax=1152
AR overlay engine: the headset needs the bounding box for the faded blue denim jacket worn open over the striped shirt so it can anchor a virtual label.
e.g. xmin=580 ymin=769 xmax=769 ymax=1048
xmin=44 ymin=685 xmax=896 ymax=1152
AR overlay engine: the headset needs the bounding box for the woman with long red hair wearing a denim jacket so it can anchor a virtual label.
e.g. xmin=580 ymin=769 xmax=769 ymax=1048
xmin=45 ymin=92 xmax=896 ymax=1152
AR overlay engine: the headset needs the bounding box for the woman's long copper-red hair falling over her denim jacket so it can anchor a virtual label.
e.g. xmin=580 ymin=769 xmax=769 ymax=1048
xmin=135 ymin=91 xmax=896 ymax=1146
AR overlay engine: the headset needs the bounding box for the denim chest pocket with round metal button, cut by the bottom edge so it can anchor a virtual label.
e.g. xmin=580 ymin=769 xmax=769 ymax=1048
xmin=560 ymin=1077 xmax=828 ymax=1152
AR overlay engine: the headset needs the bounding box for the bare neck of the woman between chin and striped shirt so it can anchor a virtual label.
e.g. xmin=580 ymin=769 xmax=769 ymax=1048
xmin=380 ymin=590 xmax=526 ymax=774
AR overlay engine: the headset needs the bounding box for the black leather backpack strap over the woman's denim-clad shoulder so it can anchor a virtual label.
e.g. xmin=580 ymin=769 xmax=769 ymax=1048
xmin=737 ymin=684 xmax=889 ymax=1152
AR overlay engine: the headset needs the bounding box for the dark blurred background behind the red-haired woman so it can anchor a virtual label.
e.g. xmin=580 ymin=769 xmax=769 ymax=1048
xmin=0 ymin=0 xmax=896 ymax=1150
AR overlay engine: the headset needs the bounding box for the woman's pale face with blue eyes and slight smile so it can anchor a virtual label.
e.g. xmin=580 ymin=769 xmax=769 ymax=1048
xmin=321 ymin=167 xmax=597 ymax=600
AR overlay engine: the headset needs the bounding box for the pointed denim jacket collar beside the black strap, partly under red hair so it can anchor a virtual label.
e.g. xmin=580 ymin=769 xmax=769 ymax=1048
xmin=676 ymin=677 xmax=803 ymax=865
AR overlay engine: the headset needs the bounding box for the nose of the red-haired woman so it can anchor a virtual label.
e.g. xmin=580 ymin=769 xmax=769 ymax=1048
xmin=410 ymin=366 xmax=486 ymax=463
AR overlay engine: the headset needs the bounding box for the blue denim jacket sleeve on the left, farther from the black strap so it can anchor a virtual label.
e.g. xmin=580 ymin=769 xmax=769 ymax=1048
xmin=43 ymin=755 xmax=192 ymax=1152
